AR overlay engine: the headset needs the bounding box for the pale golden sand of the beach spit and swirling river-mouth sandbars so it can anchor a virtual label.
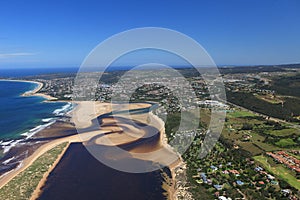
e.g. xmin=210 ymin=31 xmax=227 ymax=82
xmin=0 ymin=101 xmax=181 ymax=199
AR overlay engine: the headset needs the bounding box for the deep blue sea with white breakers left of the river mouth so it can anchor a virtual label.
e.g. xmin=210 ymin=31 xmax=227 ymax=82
xmin=0 ymin=81 xmax=71 ymax=146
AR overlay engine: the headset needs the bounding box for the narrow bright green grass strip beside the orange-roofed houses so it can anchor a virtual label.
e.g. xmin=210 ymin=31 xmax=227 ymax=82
xmin=254 ymin=155 xmax=300 ymax=190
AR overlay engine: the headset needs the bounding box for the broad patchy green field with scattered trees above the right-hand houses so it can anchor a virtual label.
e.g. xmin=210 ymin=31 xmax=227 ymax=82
xmin=218 ymin=110 xmax=300 ymax=156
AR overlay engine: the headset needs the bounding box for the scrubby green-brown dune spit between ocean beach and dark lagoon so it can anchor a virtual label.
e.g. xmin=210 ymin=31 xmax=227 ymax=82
xmin=0 ymin=143 xmax=67 ymax=200
